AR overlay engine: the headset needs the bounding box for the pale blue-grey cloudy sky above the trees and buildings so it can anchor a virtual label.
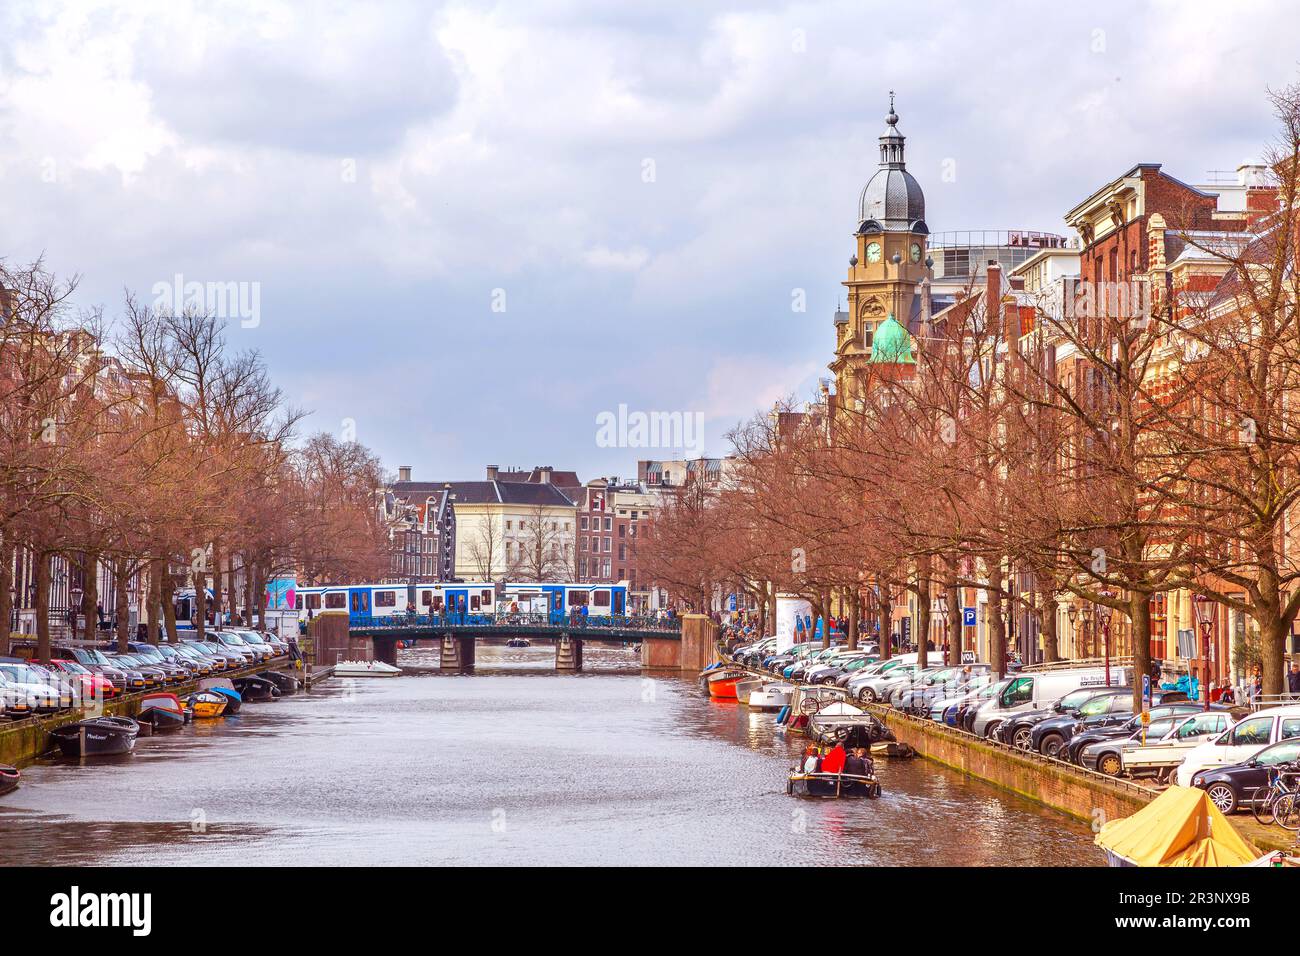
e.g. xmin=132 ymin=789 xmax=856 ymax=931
xmin=0 ymin=0 xmax=1300 ymax=480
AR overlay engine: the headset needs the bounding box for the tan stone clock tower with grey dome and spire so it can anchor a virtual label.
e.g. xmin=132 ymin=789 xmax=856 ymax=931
xmin=829 ymin=92 xmax=930 ymax=407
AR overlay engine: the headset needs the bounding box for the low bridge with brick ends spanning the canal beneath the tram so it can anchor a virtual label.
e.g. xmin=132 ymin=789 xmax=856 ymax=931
xmin=313 ymin=613 xmax=716 ymax=672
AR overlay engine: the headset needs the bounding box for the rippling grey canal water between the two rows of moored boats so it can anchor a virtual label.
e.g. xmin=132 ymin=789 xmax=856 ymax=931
xmin=0 ymin=645 xmax=1101 ymax=866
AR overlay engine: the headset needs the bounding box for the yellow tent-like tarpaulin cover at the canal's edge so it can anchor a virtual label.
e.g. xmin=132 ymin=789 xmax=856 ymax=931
xmin=1096 ymin=787 xmax=1260 ymax=866
